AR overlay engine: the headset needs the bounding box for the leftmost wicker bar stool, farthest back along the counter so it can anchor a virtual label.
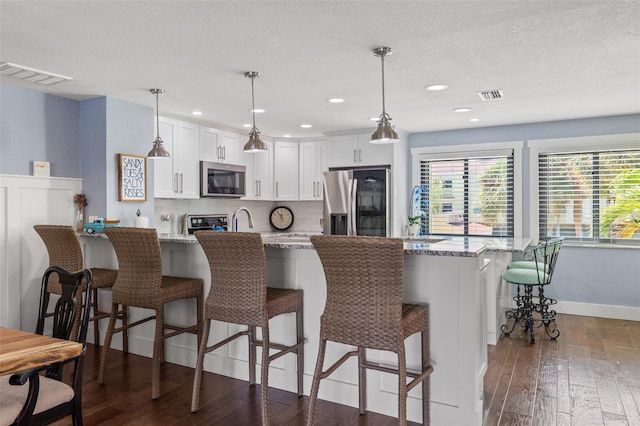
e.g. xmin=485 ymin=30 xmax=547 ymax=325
xmin=33 ymin=225 xmax=118 ymax=346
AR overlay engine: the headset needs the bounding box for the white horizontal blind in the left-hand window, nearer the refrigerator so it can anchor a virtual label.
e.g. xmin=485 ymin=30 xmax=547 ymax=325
xmin=420 ymin=151 xmax=514 ymax=237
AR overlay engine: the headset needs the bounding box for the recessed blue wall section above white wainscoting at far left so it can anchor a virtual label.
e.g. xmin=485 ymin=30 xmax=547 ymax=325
xmin=0 ymin=85 xmax=82 ymax=178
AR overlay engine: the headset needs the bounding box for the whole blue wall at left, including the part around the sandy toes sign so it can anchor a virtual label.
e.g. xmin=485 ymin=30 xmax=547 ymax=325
xmin=0 ymin=85 xmax=154 ymax=226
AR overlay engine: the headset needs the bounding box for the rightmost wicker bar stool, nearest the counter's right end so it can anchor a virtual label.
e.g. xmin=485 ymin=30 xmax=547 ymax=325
xmin=307 ymin=235 xmax=433 ymax=426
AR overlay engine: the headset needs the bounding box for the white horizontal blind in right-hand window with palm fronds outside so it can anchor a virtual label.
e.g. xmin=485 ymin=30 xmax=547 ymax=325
xmin=538 ymin=149 xmax=640 ymax=243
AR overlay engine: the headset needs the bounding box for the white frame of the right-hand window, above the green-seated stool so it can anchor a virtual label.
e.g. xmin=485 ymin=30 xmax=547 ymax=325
xmin=527 ymin=133 xmax=640 ymax=247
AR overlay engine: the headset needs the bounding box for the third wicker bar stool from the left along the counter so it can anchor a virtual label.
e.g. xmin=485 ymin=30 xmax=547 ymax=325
xmin=191 ymin=231 xmax=304 ymax=425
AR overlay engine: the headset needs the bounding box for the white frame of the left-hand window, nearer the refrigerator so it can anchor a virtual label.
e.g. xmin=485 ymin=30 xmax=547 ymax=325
xmin=411 ymin=141 xmax=524 ymax=238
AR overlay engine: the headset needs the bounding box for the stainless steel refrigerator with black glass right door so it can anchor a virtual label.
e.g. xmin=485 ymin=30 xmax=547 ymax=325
xmin=323 ymin=167 xmax=390 ymax=237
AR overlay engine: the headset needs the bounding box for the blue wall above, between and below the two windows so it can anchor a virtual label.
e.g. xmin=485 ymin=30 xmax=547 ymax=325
xmin=409 ymin=114 xmax=640 ymax=308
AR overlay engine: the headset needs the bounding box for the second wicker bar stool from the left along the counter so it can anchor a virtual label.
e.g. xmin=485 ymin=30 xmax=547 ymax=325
xmin=98 ymin=227 xmax=204 ymax=399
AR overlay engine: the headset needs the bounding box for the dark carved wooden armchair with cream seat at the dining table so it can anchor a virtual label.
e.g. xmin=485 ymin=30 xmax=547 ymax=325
xmin=0 ymin=266 xmax=92 ymax=426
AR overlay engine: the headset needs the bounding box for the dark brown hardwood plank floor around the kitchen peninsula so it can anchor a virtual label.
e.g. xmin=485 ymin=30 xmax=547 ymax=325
xmin=50 ymin=315 xmax=640 ymax=426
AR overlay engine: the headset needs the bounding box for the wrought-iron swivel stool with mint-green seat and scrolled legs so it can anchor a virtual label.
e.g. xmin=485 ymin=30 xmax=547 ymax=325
xmin=501 ymin=238 xmax=563 ymax=343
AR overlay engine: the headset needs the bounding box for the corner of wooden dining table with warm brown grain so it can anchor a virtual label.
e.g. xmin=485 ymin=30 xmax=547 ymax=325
xmin=0 ymin=327 xmax=82 ymax=376
